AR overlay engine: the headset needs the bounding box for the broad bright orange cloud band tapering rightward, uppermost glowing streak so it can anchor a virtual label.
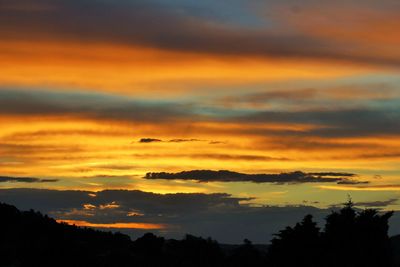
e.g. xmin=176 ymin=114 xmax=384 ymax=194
xmin=0 ymin=41 xmax=370 ymax=94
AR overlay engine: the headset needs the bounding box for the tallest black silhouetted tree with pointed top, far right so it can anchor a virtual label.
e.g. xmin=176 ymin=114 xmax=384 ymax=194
xmin=323 ymin=200 xmax=393 ymax=267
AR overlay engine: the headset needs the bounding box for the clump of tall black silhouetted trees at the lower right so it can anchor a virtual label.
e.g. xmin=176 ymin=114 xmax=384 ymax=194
xmin=268 ymin=200 xmax=393 ymax=267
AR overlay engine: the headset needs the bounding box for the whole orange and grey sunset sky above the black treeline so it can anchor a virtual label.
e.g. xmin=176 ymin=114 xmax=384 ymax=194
xmin=0 ymin=0 xmax=400 ymax=243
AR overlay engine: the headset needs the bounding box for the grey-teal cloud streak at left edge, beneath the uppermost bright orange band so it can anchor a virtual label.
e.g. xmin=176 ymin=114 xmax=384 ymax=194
xmin=0 ymin=89 xmax=194 ymax=122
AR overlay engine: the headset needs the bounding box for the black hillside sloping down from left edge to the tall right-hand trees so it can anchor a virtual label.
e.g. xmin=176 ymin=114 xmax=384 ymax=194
xmin=0 ymin=203 xmax=264 ymax=267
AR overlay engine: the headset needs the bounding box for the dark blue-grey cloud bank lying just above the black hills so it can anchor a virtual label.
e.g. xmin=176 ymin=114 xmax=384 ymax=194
xmin=0 ymin=189 xmax=400 ymax=243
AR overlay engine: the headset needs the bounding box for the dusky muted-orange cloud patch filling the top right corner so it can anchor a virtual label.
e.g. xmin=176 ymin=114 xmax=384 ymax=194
xmin=274 ymin=1 xmax=400 ymax=66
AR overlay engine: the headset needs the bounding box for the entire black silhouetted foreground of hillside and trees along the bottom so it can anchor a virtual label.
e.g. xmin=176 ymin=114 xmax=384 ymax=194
xmin=0 ymin=202 xmax=400 ymax=267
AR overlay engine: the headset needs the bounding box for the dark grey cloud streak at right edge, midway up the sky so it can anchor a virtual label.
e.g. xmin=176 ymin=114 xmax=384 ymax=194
xmin=230 ymin=107 xmax=400 ymax=138
